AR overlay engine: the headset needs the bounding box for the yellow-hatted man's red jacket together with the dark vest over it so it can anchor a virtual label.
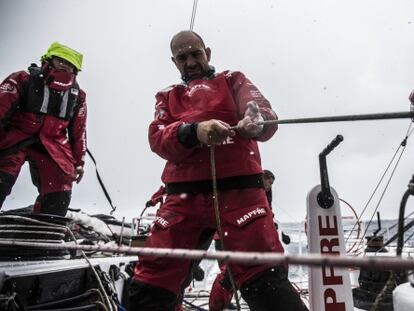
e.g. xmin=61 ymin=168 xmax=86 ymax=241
xmin=0 ymin=71 xmax=86 ymax=174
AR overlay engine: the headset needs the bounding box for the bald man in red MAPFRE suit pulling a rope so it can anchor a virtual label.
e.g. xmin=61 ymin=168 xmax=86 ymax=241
xmin=130 ymin=31 xmax=308 ymax=311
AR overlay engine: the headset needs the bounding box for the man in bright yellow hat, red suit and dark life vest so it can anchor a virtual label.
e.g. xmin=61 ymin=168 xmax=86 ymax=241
xmin=0 ymin=42 xmax=86 ymax=216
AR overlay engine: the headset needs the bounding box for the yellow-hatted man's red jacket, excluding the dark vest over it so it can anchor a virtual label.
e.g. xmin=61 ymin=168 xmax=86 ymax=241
xmin=0 ymin=71 xmax=86 ymax=174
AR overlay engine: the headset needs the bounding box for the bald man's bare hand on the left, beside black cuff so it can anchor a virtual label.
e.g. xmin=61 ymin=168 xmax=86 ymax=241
xmin=197 ymin=119 xmax=236 ymax=145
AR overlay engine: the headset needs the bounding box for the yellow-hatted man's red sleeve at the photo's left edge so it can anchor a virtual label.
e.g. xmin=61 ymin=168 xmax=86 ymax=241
xmin=0 ymin=71 xmax=29 ymax=129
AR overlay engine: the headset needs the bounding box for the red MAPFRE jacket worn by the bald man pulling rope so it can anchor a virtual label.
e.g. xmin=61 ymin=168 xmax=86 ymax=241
xmin=149 ymin=71 xmax=277 ymax=183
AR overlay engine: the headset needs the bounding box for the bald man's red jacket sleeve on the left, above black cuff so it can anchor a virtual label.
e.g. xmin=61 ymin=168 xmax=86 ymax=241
xmin=148 ymin=93 xmax=198 ymax=162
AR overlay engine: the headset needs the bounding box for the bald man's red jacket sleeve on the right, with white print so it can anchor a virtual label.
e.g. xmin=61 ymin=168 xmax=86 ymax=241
xmin=229 ymin=72 xmax=277 ymax=141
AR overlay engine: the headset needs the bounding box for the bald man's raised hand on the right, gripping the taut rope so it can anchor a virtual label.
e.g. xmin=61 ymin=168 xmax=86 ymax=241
xmin=237 ymin=101 xmax=264 ymax=138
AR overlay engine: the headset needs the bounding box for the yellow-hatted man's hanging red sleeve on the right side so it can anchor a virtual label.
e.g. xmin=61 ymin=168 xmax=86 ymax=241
xmin=68 ymin=90 xmax=87 ymax=167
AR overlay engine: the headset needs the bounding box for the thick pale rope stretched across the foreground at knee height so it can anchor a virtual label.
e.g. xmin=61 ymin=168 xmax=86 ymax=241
xmin=0 ymin=240 xmax=414 ymax=270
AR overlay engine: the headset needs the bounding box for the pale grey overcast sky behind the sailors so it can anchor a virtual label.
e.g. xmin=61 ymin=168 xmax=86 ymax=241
xmin=0 ymin=0 xmax=414 ymax=221
